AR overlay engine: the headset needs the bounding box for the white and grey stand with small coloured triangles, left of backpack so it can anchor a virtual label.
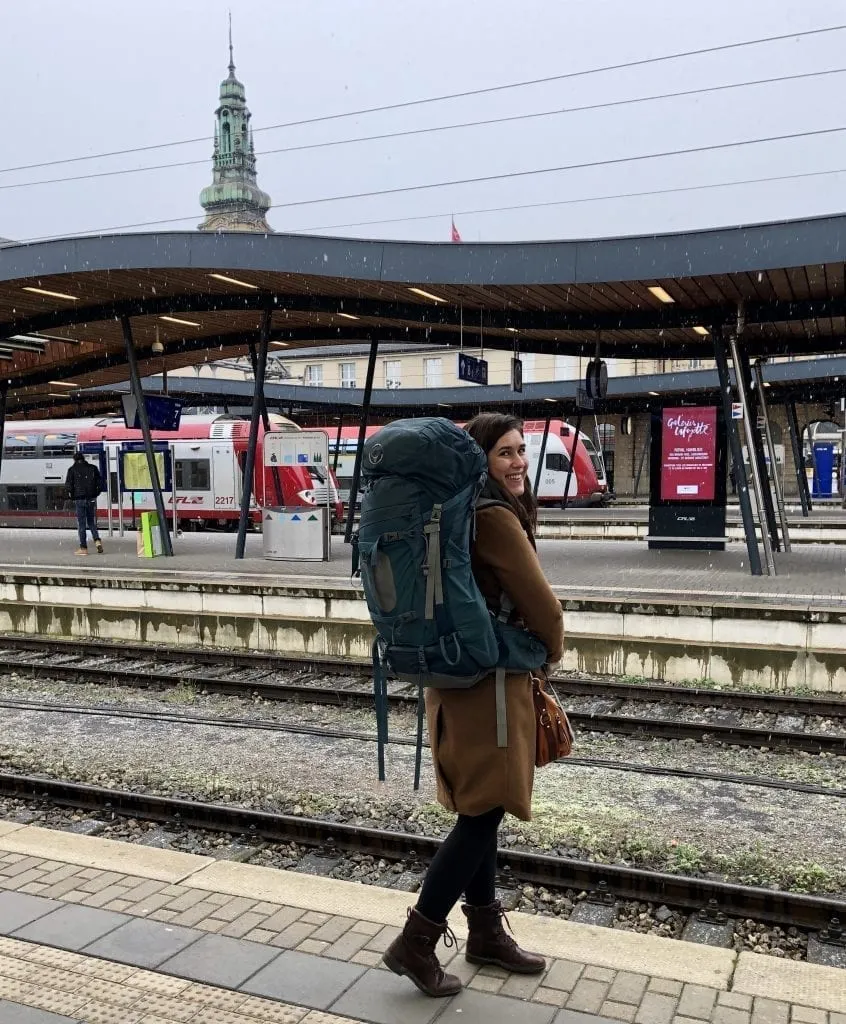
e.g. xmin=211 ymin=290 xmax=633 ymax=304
xmin=262 ymin=430 xmax=332 ymax=561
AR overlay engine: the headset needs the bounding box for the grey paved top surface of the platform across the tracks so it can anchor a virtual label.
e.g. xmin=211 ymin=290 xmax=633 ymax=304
xmin=0 ymin=529 xmax=846 ymax=605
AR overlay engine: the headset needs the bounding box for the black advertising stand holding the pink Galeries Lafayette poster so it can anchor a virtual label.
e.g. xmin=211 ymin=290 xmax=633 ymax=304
xmin=646 ymin=406 xmax=726 ymax=551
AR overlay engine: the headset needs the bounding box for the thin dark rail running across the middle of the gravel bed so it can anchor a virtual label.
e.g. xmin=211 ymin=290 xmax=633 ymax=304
xmin=0 ymin=698 xmax=846 ymax=800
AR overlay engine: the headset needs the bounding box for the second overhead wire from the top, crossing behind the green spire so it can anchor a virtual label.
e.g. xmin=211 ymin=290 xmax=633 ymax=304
xmin=0 ymin=68 xmax=846 ymax=190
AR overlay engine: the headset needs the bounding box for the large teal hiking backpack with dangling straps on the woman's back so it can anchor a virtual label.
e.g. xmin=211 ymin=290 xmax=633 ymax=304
xmin=352 ymin=417 xmax=547 ymax=790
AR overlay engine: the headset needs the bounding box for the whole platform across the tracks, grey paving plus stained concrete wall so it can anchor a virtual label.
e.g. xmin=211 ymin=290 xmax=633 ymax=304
xmin=0 ymin=530 xmax=846 ymax=692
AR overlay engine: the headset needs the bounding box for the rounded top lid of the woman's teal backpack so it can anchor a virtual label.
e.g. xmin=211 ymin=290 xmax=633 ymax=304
xmin=362 ymin=416 xmax=488 ymax=501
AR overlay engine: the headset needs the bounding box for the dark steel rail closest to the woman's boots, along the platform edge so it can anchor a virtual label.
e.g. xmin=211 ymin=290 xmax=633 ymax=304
xmin=0 ymin=772 xmax=846 ymax=930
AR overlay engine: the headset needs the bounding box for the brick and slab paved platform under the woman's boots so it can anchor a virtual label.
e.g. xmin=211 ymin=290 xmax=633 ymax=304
xmin=0 ymin=821 xmax=846 ymax=1024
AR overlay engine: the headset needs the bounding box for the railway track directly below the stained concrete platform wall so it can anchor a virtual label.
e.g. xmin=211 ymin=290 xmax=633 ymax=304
xmin=0 ymin=636 xmax=846 ymax=756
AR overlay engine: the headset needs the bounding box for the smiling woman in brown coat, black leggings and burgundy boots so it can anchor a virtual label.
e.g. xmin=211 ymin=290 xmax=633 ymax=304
xmin=384 ymin=413 xmax=563 ymax=995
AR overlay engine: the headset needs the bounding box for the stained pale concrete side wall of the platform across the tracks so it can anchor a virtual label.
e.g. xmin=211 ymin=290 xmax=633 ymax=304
xmin=0 ymin=573 xmax=846 ymax=692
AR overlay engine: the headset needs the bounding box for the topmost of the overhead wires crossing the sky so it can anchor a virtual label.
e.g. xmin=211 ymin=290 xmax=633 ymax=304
xmin=0 ymin=25 xmax=846 ymax=174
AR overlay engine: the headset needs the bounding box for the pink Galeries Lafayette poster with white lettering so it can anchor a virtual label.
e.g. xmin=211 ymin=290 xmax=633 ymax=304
xmin=661 ymin=406 xmax=717 ymax=502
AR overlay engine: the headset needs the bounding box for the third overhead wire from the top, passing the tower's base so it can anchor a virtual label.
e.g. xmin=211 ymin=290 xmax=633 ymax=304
xmin=14 ymin=126 xmax=846 ymax=243
